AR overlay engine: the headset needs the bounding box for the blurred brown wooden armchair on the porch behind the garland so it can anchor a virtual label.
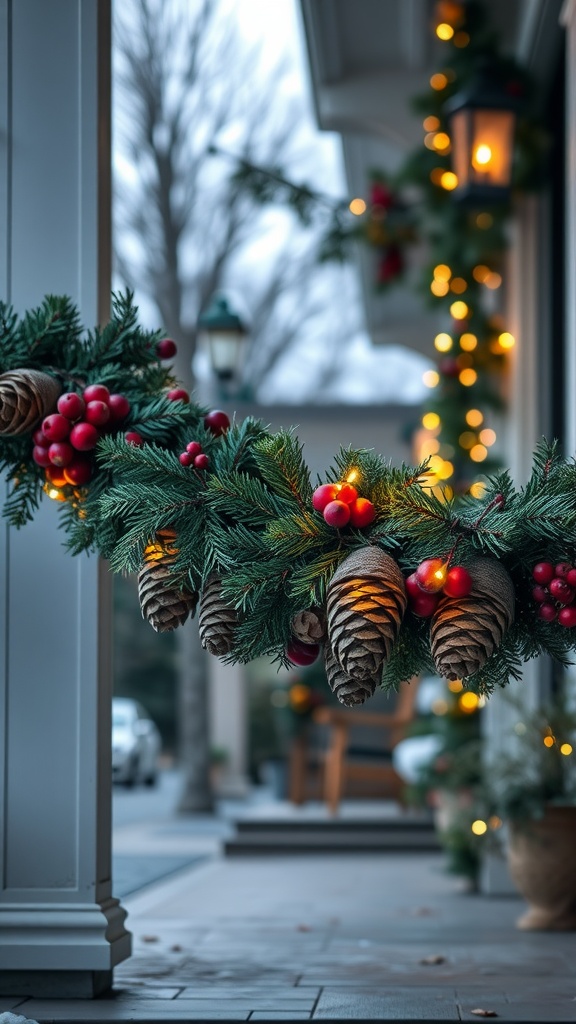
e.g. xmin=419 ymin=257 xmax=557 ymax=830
xmin=289 ymin=679 xmax=418 ymax=814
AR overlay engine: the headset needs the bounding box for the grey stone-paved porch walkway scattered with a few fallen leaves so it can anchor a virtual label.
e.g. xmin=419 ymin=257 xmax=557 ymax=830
xmin=0 ymin=802 xmax=576 ymax=1024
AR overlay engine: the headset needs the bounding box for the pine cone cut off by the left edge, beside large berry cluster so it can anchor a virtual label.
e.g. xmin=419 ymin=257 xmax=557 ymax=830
xmin=0 ymin=370 xmax=61 ymax=435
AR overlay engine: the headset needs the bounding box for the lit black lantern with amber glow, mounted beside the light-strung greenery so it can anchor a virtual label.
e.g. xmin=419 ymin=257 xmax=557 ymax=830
xmin=446 ymin=77 xmax=518 ymax=206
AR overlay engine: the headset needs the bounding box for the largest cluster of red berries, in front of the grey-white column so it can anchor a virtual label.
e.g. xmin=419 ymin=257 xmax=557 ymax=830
xmin=32 ymin=384 xmax=130 ymax=487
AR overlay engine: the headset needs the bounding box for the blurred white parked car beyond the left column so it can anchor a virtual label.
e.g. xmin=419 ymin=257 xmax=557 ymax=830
xmin=112 ymin=697 xmax=161 ymax=785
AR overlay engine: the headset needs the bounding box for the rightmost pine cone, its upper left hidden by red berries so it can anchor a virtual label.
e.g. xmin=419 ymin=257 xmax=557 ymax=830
xmin=430 ymin=558 xmax=515 ymax=679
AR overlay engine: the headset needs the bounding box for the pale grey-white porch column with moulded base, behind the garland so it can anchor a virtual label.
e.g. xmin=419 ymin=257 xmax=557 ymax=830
xmin=0 ymin=0 xmax=130 ymax=996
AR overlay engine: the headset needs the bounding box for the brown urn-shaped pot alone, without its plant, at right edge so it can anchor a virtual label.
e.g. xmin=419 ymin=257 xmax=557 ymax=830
xmin=507 ymin=806 xmax=576 ymax=932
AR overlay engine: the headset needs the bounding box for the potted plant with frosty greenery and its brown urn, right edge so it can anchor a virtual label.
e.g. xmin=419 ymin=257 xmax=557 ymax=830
xmin=490 ymin=698 xmax=576 ymax=931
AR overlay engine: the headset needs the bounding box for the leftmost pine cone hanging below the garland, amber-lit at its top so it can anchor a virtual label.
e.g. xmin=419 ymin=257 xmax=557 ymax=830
xmin=138 ymin=529 xmax=198 ymax=633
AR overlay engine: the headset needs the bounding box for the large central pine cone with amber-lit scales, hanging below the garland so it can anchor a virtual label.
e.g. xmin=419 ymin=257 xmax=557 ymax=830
xmin=327 ymin=547 xmax=406 ymax=680
